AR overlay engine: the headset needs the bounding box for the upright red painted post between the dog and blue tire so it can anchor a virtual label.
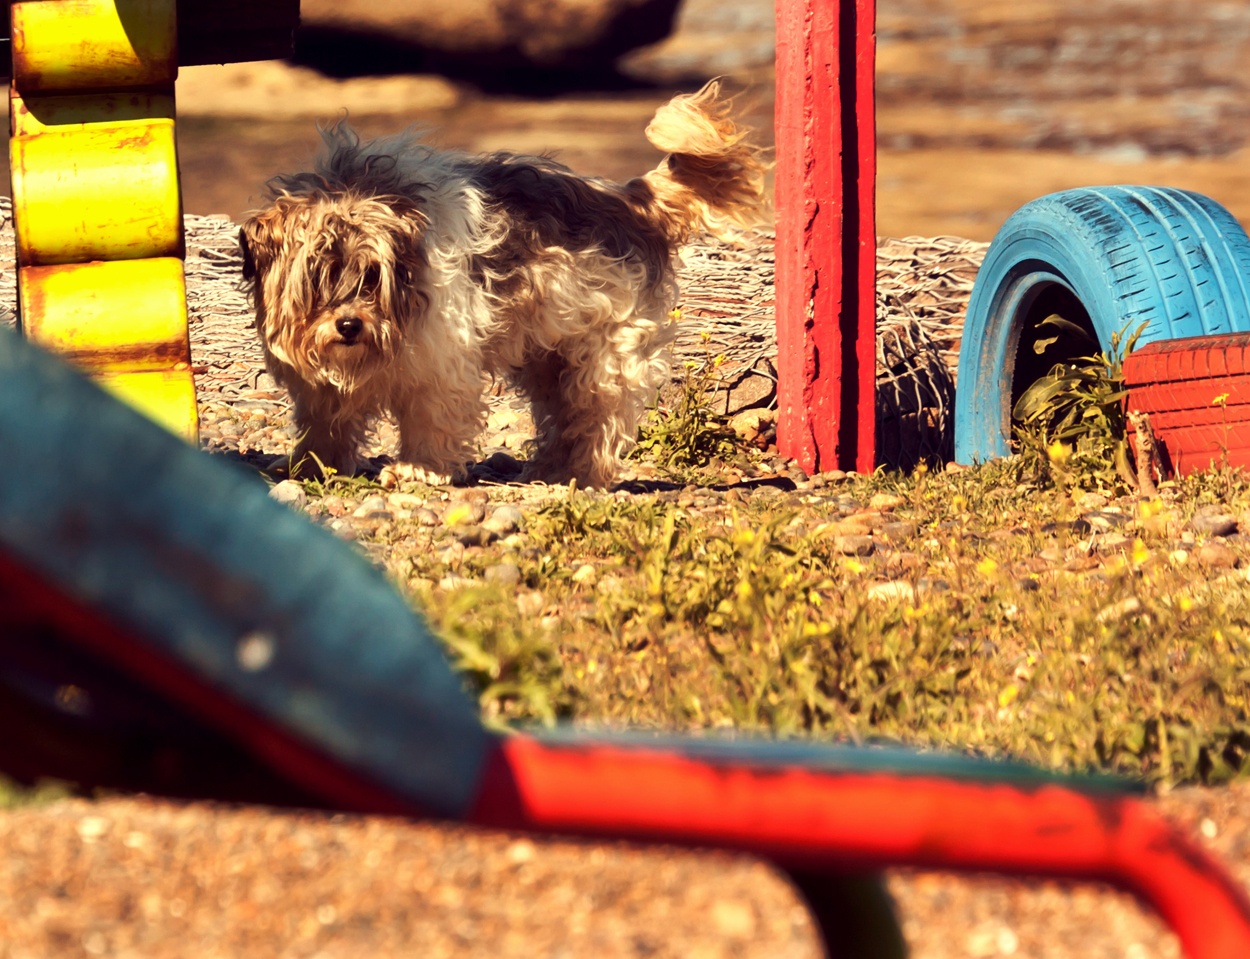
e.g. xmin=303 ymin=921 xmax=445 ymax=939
xmin=776 ymin=0 xmax=876 ymax=471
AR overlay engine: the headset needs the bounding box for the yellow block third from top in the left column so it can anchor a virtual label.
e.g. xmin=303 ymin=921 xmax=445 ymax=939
xmin=18 ymin=256 xmax=191 ymax=373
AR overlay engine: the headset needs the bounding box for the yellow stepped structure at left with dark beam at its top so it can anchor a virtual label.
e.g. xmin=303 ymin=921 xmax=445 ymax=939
xmin=9 ymin=0 xmax=299 ymax=443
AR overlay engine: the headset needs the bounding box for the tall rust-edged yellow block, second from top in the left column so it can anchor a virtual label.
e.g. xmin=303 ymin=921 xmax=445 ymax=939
xmin=9 ymin=105 xmax=183 ymax=265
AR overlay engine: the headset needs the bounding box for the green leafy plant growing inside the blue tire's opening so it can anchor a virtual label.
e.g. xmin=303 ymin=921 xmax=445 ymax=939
xmin=1011 ymin=314 xmax=1145 ymax=491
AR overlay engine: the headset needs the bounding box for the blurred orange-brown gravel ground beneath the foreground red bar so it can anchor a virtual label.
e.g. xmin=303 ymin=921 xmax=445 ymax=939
xmin=0 ymin=784 xmax=1250 ymax=959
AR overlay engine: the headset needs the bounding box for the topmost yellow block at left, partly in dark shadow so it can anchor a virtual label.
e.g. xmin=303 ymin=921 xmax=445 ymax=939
xmin=10 ymin=0 xmax=178 ymax=94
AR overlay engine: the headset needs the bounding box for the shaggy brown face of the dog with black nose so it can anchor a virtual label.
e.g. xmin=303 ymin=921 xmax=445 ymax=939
xmin=239 ymin=193 xmax=429 ymax=391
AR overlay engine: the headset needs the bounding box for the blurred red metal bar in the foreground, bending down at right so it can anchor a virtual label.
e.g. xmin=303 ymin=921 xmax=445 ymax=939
xmin=469 ymin=736 xmax=1250 ymax=959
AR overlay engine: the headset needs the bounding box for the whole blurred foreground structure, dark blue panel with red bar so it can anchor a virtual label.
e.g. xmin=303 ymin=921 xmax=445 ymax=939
xmin=0 ymin=331 xmax=1250 ymax=959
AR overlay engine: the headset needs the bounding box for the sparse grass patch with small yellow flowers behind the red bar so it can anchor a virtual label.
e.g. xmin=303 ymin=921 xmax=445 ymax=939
xmin=377 ymin=459 xmax=1250 ymax=784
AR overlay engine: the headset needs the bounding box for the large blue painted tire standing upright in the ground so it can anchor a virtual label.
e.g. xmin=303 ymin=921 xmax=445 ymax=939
xmin=955 ymin=186 xmax=1250 ymax=463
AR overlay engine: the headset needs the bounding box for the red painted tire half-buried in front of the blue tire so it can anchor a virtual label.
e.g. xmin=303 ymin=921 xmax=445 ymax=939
xmin=1124 ymin=333 xmax=1250 ymax=475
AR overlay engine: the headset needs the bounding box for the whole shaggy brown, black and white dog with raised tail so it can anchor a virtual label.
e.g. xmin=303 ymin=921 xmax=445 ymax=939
xmin=240 ymin=81 xmax=764 ymax=486
